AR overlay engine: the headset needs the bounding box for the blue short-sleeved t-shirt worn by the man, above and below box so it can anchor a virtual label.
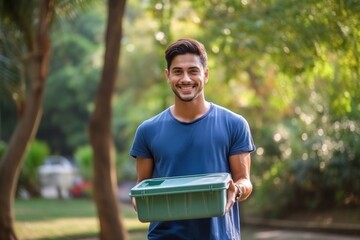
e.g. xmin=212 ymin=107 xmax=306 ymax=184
xmin=130 ymin=103 xmax=255 ymax=240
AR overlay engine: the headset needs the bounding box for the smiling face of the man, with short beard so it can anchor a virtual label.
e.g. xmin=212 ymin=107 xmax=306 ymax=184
xmin=166 ymin=54 xmax=208 ymax=102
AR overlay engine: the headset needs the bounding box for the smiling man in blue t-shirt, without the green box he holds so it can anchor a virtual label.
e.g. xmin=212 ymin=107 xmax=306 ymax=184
xmin=130 ymin=39 xmax=255 ymax=240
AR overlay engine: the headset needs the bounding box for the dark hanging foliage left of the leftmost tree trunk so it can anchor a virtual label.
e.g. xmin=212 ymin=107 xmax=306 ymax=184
xmin=0 ymin=1 xmax=31 ymax=119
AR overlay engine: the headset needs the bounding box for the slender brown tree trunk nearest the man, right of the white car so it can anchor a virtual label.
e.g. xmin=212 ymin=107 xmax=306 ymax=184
xmin=89 ymin=0 xmax=127 ymax=240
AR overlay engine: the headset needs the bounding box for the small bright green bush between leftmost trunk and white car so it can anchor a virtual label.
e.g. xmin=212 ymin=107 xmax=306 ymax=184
xmin=18 ymin=140 xmax=50 ymax=196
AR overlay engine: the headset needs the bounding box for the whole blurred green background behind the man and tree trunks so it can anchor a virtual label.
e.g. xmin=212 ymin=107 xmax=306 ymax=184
xmin=0 ymin=0 xmax=360 ymax=240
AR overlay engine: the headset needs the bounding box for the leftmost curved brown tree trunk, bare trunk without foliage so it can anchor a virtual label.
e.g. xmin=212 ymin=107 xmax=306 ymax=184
xmin=0 ymin=0 xmax=53 ymax=240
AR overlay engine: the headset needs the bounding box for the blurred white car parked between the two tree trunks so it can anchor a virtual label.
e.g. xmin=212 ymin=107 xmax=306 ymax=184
xmin=38 ymin=156 xmax=78 ymax=198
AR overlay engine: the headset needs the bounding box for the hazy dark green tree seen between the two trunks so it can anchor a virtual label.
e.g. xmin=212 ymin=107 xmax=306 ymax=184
xmin=37 ymin=7 xmax=106 ymax=154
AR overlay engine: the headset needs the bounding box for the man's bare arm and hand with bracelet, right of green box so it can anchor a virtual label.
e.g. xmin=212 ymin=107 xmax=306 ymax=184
xmin=226 ymin=153 xmax=253 ymax=209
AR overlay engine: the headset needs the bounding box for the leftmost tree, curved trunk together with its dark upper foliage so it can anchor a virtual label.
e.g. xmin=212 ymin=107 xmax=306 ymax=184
xmin=0 ymin=0 xmax=97 ymax=240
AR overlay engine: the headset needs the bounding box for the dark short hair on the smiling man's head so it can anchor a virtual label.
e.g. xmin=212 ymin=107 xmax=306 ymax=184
xmin=165 ymin=38 xmax=207 ymax=70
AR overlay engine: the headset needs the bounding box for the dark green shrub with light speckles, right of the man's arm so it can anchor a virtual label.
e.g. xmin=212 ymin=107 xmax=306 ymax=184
xmin=252 ymin=112 xmax=360 ymax=217
